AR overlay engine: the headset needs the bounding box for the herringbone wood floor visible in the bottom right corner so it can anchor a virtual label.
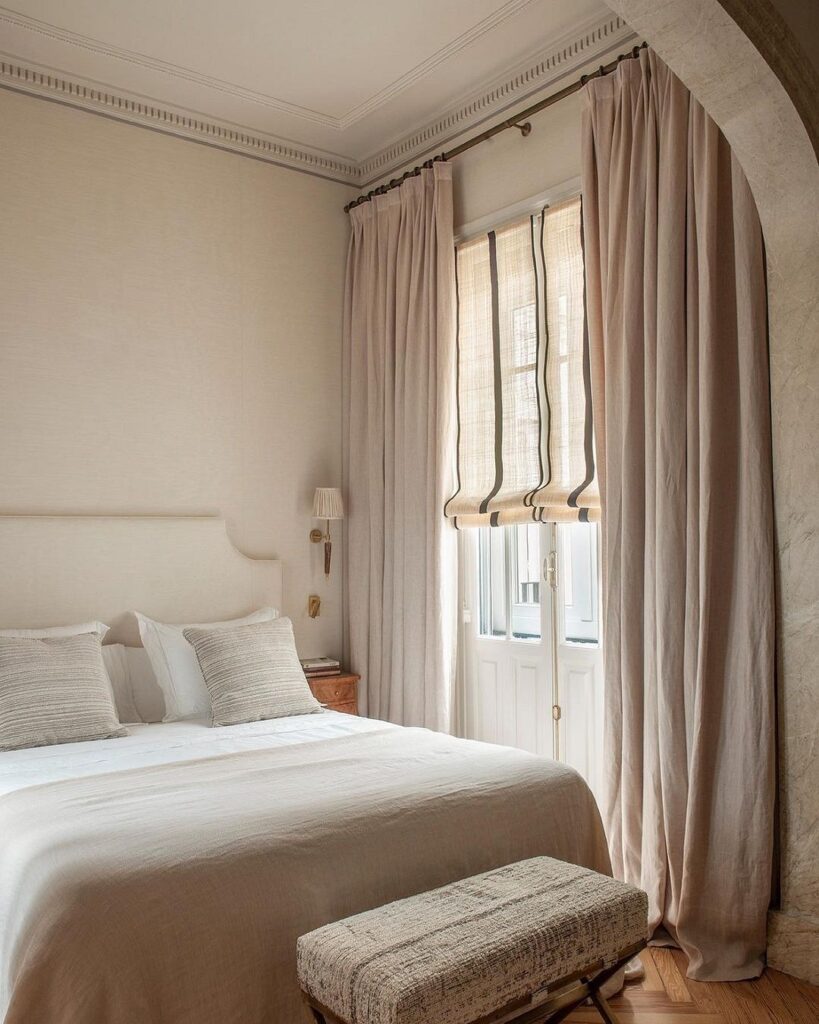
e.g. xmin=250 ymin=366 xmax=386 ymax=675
xmin=566 ymin=949 xmax=819 ymax=1024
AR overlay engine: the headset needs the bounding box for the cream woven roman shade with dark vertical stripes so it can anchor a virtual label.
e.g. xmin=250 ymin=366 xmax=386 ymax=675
xmin=444 ymin=198 xmax=600 ymax=526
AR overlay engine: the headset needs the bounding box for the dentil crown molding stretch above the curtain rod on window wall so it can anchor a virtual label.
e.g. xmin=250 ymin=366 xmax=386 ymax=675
xmin=358 ymin=14 xmax=637 ymax=188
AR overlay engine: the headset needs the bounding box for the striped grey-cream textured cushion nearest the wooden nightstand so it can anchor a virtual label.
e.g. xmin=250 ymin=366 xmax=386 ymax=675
xmin=184 ymin=618 xmax=321 ymax=725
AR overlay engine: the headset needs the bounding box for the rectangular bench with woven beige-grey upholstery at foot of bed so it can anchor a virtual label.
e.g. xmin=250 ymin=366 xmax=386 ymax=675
xmin=298 ymin=857 xmax=648 ymax=1024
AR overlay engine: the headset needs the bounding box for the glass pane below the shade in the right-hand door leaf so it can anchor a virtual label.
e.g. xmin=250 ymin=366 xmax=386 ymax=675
xmin=557 ymin=522 xmax=600 ymax=643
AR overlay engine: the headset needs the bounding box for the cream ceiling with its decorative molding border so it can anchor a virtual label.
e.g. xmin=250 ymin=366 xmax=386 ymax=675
xmin=0 ymin=0 xmax=631 ymax=184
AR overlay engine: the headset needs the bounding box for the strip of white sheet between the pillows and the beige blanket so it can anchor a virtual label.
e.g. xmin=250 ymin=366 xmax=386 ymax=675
xmin=0 ymin=711 xmax=386 ymax=797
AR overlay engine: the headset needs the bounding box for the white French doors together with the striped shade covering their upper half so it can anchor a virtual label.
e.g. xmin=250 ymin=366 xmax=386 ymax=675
xmin=464 ymin=199 xmax=603 ymax=780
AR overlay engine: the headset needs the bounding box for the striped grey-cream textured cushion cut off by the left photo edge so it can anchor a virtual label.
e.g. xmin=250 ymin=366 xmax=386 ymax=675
xmin=0 ymin=633 xmax=125 ymax=751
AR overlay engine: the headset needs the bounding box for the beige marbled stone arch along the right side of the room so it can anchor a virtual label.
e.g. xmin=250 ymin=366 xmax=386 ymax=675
xmin=609 ymin=0 xmax=819 ymax=982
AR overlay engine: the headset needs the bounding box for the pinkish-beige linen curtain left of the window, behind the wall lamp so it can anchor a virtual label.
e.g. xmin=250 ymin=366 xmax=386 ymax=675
xmin=343 ymin=163 xmax=457 ymax=731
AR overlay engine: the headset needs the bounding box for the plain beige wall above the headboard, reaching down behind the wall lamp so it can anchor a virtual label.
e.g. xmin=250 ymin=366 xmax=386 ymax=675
xmin=0 ymin=90 xmax=349 ymax=654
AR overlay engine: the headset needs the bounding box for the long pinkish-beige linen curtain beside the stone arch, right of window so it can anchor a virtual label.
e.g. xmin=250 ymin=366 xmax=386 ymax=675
xmin=583 ymin=50 xmax=774 ymax=981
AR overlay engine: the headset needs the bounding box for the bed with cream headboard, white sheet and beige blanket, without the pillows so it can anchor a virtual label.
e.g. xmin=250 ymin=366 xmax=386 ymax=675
xmin=0 ymin=517 xmax=609 ymax=1024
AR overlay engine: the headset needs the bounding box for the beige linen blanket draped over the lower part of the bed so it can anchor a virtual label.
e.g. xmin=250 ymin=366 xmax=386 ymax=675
xmin=0 ymin=728 xmax=609 ymax=1024
